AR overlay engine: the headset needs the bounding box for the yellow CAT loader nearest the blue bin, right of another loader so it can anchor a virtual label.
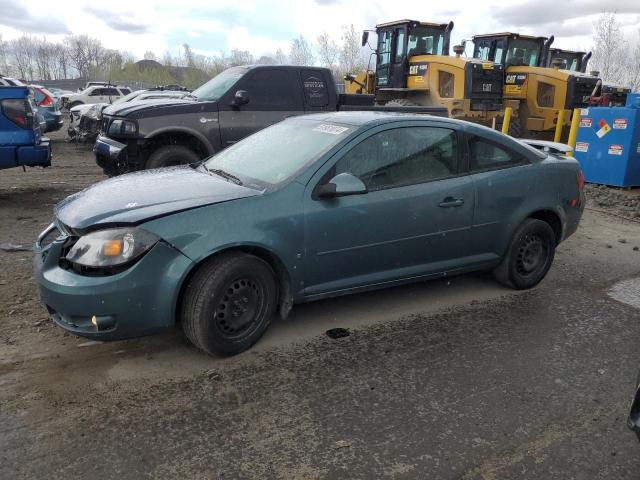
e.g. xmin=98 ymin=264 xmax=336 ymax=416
xmin=473 ymin=32 xmax=602 ymax=138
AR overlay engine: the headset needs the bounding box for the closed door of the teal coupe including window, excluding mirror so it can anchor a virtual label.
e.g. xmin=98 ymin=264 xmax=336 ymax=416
xmin=304 ymin=123 xmax=474 ymax=295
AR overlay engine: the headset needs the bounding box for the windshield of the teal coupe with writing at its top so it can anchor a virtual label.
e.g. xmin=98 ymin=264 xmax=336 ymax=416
xmin=204 ymin=118 xmax=355 ymax=189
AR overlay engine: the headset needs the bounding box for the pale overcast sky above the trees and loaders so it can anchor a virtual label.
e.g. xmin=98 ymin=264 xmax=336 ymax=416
xmin=0 ymin=0 xmax=640 ymax=57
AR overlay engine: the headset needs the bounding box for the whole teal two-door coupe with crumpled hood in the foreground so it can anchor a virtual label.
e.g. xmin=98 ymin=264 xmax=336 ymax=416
xmin=35 ymin=112 xmax=585 ymax=355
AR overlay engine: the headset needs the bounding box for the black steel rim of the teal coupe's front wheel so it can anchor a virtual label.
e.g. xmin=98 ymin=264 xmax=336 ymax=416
xmin=213 ymin=277 xmax=265 ymax=338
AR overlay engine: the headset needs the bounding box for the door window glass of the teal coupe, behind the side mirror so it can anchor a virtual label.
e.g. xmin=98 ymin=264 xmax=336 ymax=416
xmin=333 ymin=127 xmax=458 ymax=191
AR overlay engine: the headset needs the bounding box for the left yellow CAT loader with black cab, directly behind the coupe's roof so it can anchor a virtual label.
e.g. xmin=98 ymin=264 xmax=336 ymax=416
xmin=345 ymin=20 xmax=504 ymax=124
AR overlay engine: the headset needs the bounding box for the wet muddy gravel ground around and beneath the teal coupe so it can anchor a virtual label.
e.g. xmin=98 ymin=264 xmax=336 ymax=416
xmin=0 ymin=125 xmax=640 ymax=479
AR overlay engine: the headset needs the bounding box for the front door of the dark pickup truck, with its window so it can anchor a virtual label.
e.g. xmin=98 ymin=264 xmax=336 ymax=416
xmin=219 ymin=68 xmax=304 ymax=146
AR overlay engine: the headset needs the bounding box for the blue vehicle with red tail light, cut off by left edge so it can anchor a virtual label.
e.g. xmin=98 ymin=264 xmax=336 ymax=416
xmin=0 ymin=86 xmax=51 ymax=169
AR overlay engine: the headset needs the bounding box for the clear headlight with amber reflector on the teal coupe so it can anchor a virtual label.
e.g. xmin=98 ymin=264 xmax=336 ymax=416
xmin=65 ymin=227 xmax=159 ymax=267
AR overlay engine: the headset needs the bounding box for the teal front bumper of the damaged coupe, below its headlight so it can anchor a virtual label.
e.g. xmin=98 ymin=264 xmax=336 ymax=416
xmin=34 ymin=227 xmax=192 ymax=340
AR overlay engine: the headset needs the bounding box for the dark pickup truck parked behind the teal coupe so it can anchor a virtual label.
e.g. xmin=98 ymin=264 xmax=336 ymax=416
xmin=93 ymin=65 xmax=447 ymax=176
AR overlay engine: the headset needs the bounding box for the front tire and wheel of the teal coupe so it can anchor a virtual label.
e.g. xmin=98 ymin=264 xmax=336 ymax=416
xmin=181 ymin=253 xmax=278 ymax=356
